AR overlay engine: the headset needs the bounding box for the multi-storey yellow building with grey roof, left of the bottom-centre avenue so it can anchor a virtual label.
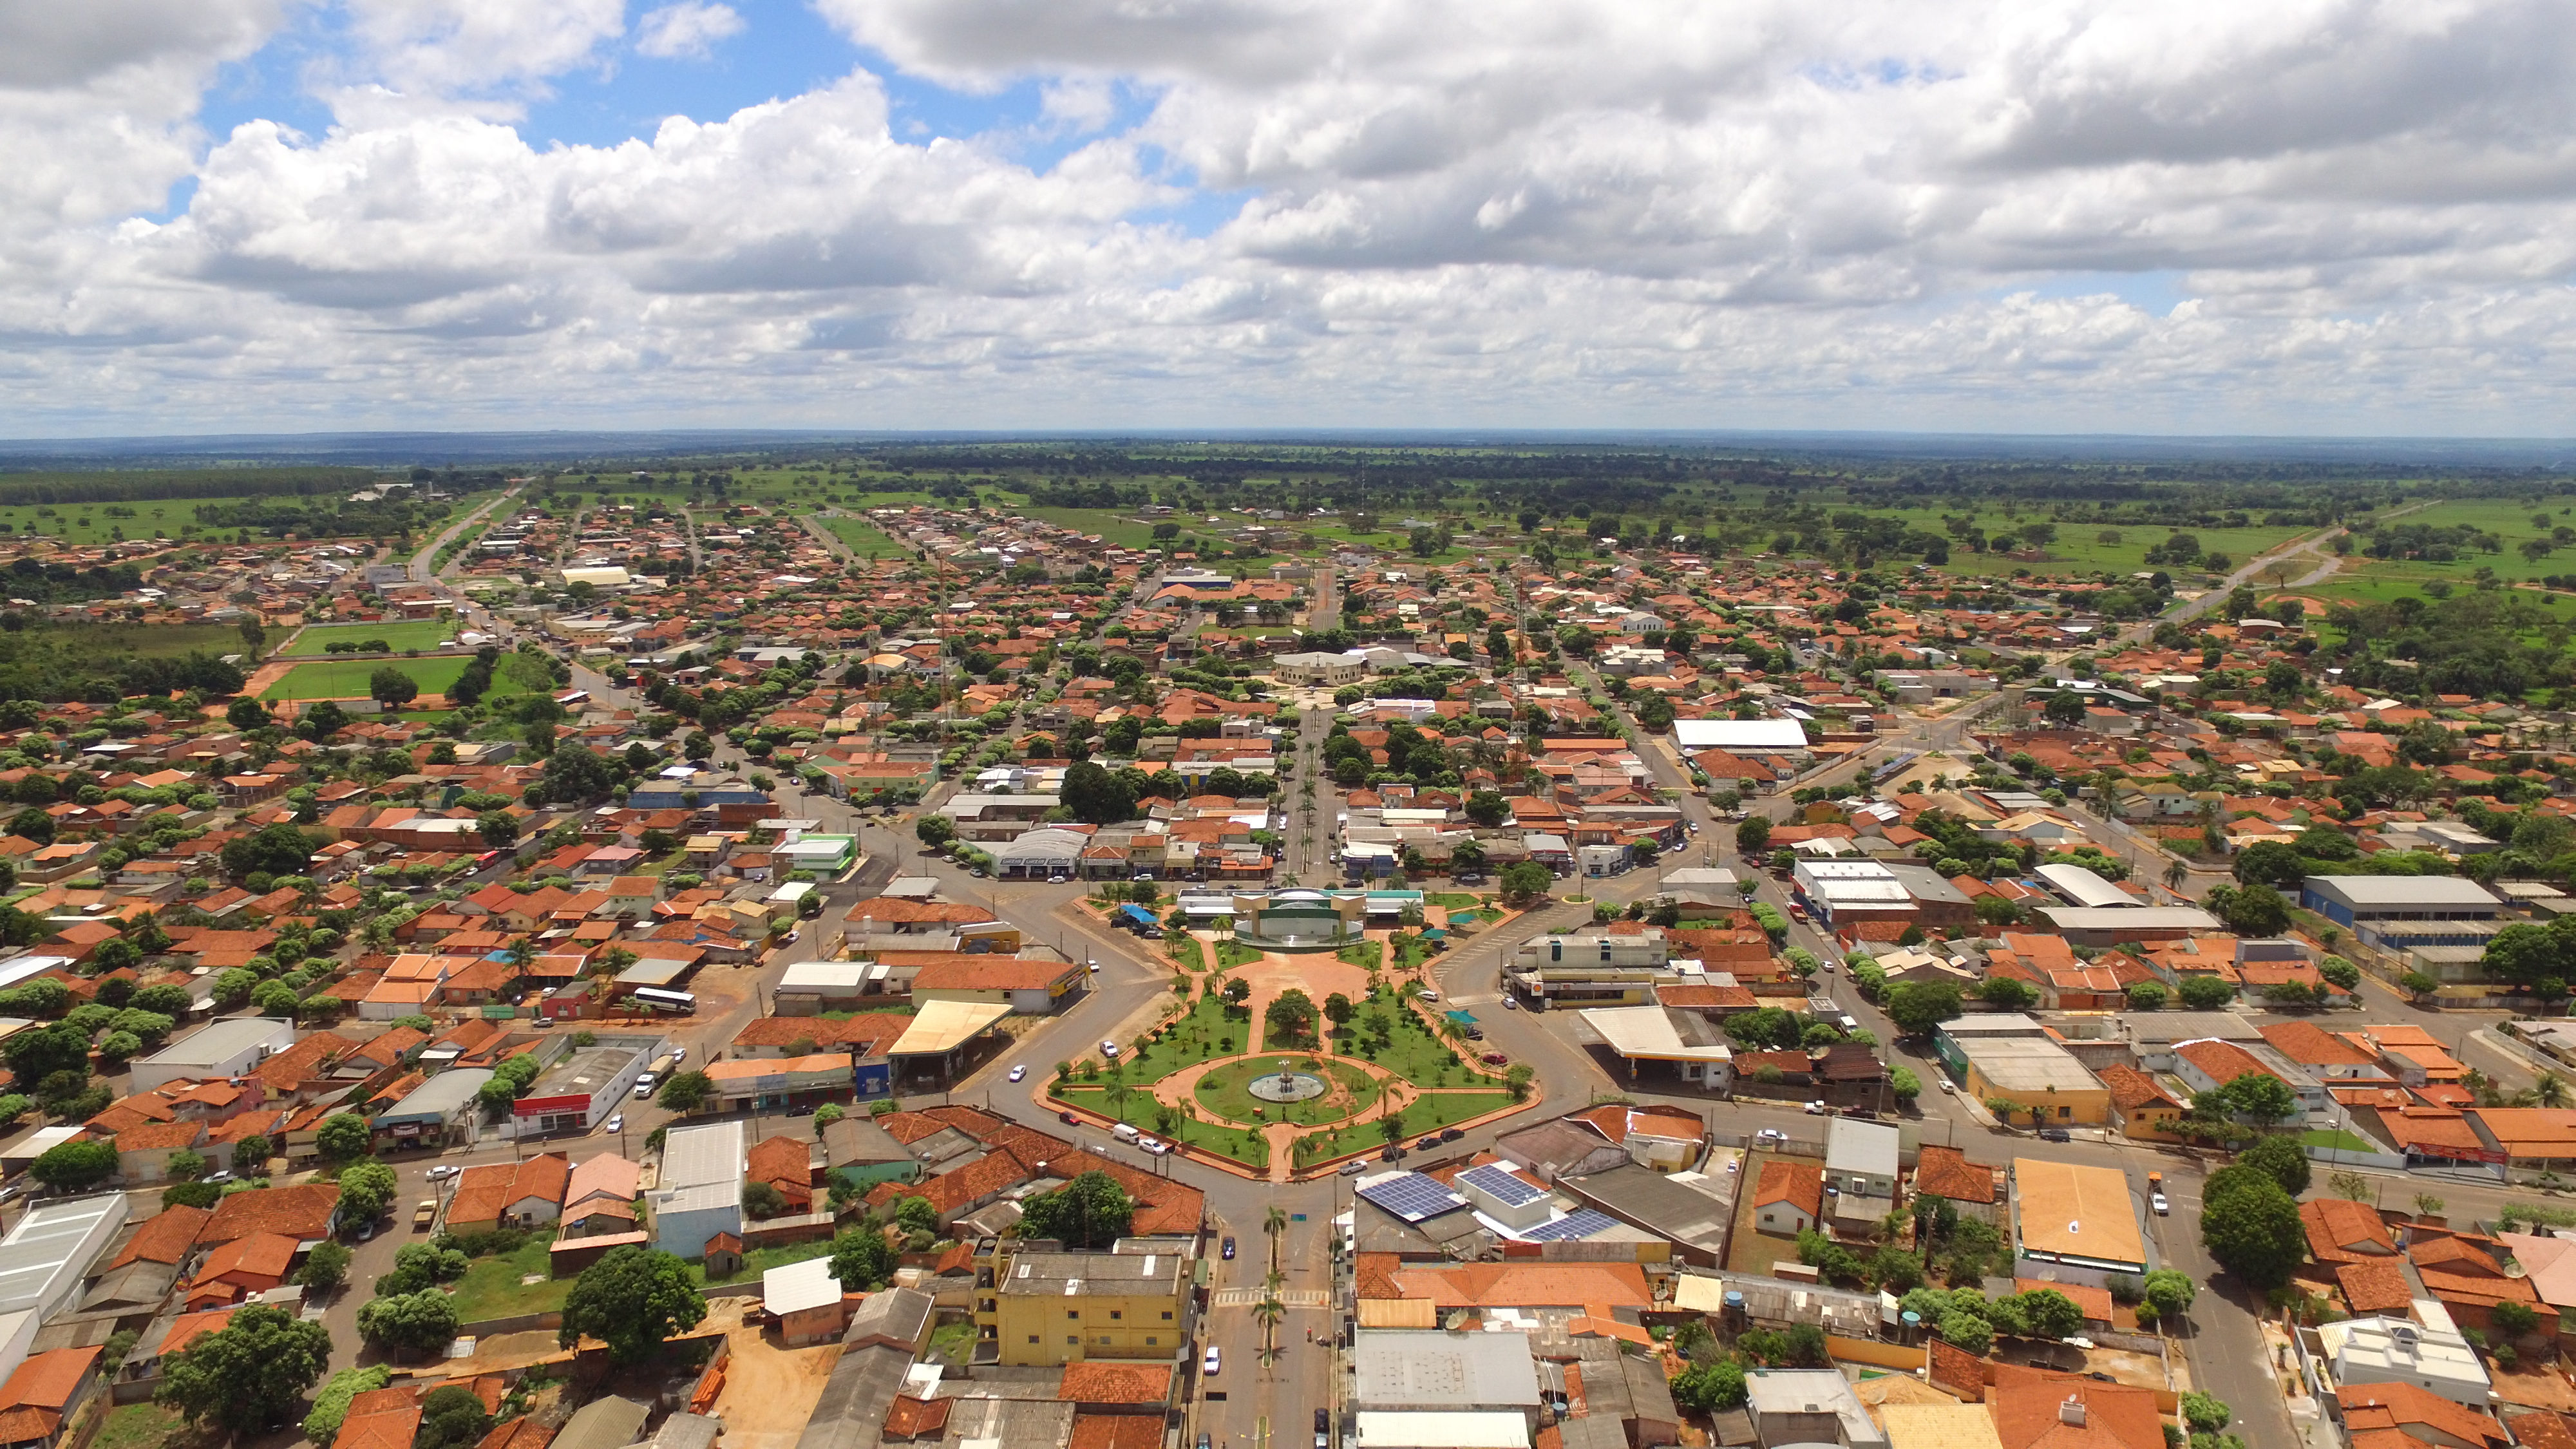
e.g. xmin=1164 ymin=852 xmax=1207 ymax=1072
xmin=974 ymin=1243 xmax=1193 ymax=1367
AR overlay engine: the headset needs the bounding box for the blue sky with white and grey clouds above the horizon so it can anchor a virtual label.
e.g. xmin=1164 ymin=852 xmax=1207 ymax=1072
xmin=0 ymin=0 xmax=2576 ymax=436
